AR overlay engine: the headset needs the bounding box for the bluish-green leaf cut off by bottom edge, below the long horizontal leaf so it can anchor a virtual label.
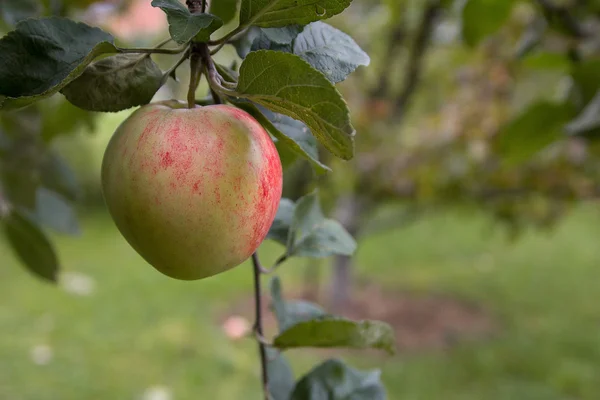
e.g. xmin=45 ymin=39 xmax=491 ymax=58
xmin=291 ymin=360 xmax=386 ymax=400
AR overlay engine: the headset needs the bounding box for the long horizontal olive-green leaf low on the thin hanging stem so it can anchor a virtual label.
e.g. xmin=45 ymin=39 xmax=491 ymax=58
xmin=273 ymin=317 xmax=395 ymax=354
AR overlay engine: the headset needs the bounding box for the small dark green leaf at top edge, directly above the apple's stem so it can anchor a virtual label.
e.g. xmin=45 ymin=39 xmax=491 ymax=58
xmin=151 ymin=0 xmax=223 ymax=44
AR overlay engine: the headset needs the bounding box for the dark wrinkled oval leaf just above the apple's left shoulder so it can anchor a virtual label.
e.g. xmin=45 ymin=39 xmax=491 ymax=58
xmin=61 ymin=54 xmax=163 ymax=112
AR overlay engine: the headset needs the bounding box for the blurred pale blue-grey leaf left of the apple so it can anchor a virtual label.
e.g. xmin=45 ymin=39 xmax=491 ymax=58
xmin=35 ymin=187 xmax=81 ymax=236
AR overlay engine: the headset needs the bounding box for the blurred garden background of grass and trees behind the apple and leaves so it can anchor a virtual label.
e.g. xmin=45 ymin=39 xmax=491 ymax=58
xmin=5 ymin=0 xmax=600 ymax=400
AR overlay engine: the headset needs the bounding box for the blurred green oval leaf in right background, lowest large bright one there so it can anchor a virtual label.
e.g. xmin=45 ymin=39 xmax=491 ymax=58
xmin=496 ymin=102 xmax=573 ymax=165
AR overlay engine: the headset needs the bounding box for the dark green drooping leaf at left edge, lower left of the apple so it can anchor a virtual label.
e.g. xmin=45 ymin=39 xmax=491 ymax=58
xmin=2 ymin=209 xmax=58 ymax=282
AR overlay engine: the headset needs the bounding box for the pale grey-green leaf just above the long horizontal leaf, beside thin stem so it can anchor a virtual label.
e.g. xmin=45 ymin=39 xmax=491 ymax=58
xmin=271 ymin=277 xmax=326 ymax=332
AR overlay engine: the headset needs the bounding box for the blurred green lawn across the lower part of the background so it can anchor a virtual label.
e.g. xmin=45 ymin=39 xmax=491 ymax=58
xmin=0 ymin=208 xmax=600 ymax=400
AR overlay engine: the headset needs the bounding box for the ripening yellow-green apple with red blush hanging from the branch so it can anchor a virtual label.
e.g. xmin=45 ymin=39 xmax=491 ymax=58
xmin=102 ymin=101 xmax=282 ymax=280
